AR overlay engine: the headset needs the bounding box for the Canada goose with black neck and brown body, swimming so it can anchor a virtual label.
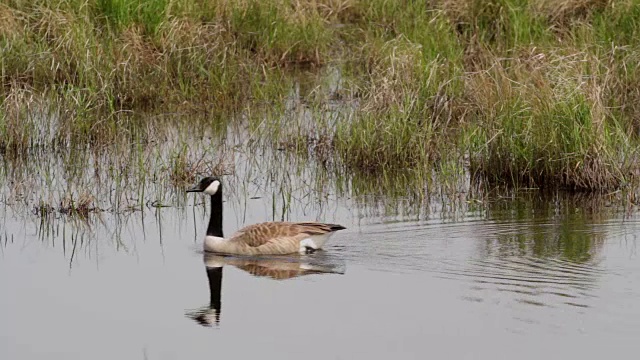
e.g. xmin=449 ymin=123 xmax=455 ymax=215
xmin=187 ymin=177 xmax=345 ymax=255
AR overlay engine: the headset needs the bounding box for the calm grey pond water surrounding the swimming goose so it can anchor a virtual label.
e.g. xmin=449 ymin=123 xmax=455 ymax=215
xmin=0 ymin=169 xmax=640 ymax=359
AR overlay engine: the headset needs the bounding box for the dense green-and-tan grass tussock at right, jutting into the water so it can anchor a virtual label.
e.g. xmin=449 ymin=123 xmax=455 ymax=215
xmin=468 ymin=52 xmax=633 ymax=190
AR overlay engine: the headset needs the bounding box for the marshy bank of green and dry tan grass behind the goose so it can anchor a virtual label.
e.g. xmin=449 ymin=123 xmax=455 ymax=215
xmin=0 ymin=0 xmax=640 ymax=191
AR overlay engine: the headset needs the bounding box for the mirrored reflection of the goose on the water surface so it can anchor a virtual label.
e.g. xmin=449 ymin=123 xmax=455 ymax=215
xmin=186 ymin=251 xmax=345 ymax=327
